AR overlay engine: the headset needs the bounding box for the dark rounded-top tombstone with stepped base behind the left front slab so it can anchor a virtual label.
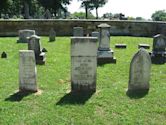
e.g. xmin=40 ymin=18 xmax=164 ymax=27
xmin=28 ymin=35 xmax=46 ymax=64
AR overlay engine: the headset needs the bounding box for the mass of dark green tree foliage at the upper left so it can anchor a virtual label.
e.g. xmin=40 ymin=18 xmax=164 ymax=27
xmin=0 ymin=0 xmax=71 ymax=18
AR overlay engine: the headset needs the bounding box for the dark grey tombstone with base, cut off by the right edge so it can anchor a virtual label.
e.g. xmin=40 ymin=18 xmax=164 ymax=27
xmin=150 ymin=34 xmax=166 ymax=64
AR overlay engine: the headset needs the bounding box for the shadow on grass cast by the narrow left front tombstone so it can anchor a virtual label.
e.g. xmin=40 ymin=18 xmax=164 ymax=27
xmin=5 ymin=91 xmax=33 ymax=102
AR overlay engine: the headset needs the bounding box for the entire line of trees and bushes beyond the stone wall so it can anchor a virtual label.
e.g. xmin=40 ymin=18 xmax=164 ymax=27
xmin=0 ymin=0 xmax=166 ymax=21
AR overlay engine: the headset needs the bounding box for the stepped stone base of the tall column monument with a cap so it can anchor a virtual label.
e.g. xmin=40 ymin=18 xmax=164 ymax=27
xmin=97 ymin=50 xmax=116 ymax=65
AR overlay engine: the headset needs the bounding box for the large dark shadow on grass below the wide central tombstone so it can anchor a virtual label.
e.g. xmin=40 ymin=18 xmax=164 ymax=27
xmin=56 ymin=92 xmax=94 ymax=105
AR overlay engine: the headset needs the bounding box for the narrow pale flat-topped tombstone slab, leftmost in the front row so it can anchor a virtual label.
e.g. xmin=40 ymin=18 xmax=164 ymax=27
xmin=19 ymin=50 xmax=38 ymax=92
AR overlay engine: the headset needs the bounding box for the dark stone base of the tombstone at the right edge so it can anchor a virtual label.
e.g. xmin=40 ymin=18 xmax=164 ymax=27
xmin=149 ymin=52 xmax=166 ymax=64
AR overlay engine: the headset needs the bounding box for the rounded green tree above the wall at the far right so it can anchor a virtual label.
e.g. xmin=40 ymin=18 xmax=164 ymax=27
xmin=152 ymin=10 xmax=166 ymax=21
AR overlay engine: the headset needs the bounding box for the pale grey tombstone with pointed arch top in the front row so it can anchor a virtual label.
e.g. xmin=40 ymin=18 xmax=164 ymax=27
xmin=128 ymin=48 xmax=151 ymax=92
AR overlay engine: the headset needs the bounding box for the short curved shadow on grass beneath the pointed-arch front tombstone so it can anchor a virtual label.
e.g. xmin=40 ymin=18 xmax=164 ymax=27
xmin=126 ymin=90 xmax=149 ymax=99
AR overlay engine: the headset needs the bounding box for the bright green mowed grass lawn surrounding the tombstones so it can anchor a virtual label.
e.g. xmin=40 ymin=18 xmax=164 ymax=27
xmin=0 ymin=37 xmax=166 ymax=125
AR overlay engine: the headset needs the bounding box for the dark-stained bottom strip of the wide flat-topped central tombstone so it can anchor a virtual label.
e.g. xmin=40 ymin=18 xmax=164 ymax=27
xmin=71 ymin=83 xmax=96 ymax=93
